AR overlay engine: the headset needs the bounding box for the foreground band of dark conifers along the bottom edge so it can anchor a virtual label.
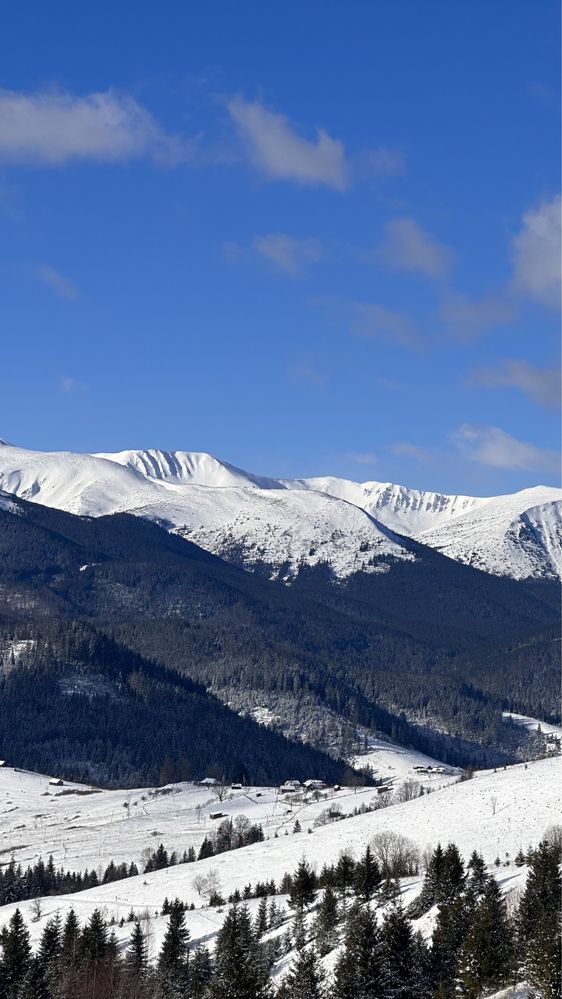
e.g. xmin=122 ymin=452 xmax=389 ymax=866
xmin=0 ymin=836 xmax=562 ymax=999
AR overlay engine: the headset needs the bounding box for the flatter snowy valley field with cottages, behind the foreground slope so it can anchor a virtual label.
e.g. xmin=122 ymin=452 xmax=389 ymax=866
xmin=0 ymin=738 xmax=459 ymax=870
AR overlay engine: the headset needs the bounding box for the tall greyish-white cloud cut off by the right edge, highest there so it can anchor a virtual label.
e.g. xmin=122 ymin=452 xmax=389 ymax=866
xmin=512 ymin=195 xmax=562 ymax=309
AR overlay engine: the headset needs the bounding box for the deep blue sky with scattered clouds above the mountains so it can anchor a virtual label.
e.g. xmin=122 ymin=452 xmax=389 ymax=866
xmin=0 ymin=0 xmax=560 ymax=494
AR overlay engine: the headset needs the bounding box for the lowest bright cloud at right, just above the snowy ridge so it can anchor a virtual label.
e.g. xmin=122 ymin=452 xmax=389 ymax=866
xmin=452 ymin=423 xmax=560 ymax=473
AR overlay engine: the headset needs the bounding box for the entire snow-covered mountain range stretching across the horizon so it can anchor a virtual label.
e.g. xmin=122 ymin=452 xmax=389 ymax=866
xmin=0 ymin=442 xmax=562 ymax=579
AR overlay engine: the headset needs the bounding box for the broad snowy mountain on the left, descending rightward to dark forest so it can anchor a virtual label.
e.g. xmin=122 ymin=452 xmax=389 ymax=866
xmin=0 ymin=447 xmax=414 ymax=577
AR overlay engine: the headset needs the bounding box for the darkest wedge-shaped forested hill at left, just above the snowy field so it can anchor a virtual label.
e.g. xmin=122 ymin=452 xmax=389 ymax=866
xmin=0 ymin=621 xmax=353 ymax=787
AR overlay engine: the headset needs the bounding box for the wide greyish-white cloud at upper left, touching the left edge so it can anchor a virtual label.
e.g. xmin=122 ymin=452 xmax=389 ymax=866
xmin=0 ymin=90 xmax=193 ymax=166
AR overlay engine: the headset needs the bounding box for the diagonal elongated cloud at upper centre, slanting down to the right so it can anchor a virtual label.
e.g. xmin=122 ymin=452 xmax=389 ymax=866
xmin=227 ymin=97 xmax=349 ymax=191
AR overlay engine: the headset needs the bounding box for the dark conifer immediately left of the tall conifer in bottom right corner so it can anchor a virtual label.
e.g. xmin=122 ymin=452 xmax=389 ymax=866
xmin=457 ymin=878 xmax=514 ymax=999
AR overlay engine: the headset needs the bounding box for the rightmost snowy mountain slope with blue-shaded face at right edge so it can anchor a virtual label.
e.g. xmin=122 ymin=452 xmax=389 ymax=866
xmin=416 ymin=486 xmax=562 ymax=579
